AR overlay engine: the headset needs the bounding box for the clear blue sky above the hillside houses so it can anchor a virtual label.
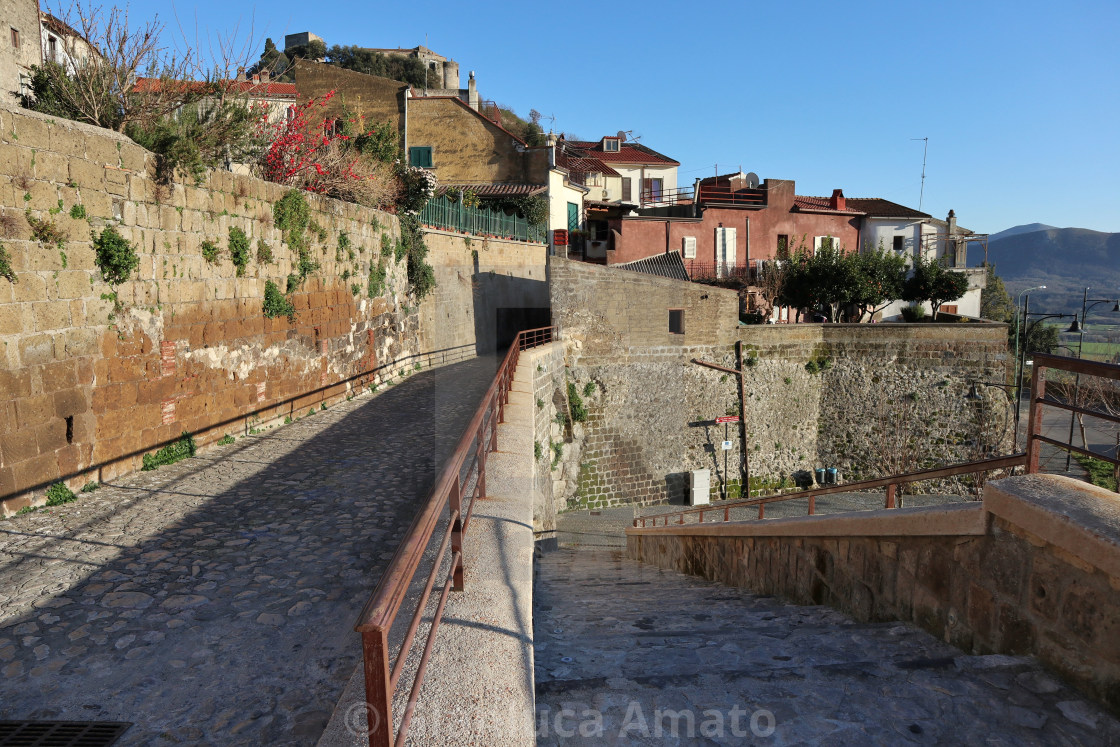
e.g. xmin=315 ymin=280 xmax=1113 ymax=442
xmin=142 ymin=0 xmax=1120 ymax=233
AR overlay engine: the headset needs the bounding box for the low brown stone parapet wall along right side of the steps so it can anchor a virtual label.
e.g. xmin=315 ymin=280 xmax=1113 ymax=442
xmin=627 ymin=475 xmax=1120 ymax=710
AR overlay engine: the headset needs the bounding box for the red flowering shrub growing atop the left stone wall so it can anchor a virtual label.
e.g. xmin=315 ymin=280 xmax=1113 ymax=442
xmin=259 ymin=91 xmax=400 ymax=208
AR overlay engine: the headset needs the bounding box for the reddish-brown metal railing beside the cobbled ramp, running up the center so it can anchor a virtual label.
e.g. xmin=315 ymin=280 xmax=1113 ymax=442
xmin=354 ymin=327 xmax=556 ymax=747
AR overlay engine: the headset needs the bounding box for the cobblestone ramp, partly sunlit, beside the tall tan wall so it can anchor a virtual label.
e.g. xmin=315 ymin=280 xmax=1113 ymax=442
xmin=0 ymin=358 xmax=496 ymax=745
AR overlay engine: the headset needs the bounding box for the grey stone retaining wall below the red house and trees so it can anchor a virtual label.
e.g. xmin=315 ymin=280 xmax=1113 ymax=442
xmin=551 ymin=259 xmax=1011 ymax=507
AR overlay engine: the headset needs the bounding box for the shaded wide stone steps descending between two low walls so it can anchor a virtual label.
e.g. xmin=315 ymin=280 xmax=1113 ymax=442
xmin=533 ymin=549 xmax=1120 ymax=745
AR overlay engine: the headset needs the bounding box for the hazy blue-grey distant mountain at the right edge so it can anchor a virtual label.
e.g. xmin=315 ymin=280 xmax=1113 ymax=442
xmin=969 ymin=223 xmax=1120 ymax=312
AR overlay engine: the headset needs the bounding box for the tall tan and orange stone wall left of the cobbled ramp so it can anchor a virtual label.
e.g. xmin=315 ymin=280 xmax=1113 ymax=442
xmin=0 ymin=106 xmax=547 ymax=512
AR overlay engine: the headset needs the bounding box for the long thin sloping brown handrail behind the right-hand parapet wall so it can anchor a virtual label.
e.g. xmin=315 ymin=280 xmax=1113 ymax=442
xmin=634 ymin=452 xmax=1027 ymax=526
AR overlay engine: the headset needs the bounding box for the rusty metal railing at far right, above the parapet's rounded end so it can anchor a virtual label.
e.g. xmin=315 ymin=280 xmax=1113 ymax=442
xmin=1027 ymin=353 xmax=1120 ymax=473
